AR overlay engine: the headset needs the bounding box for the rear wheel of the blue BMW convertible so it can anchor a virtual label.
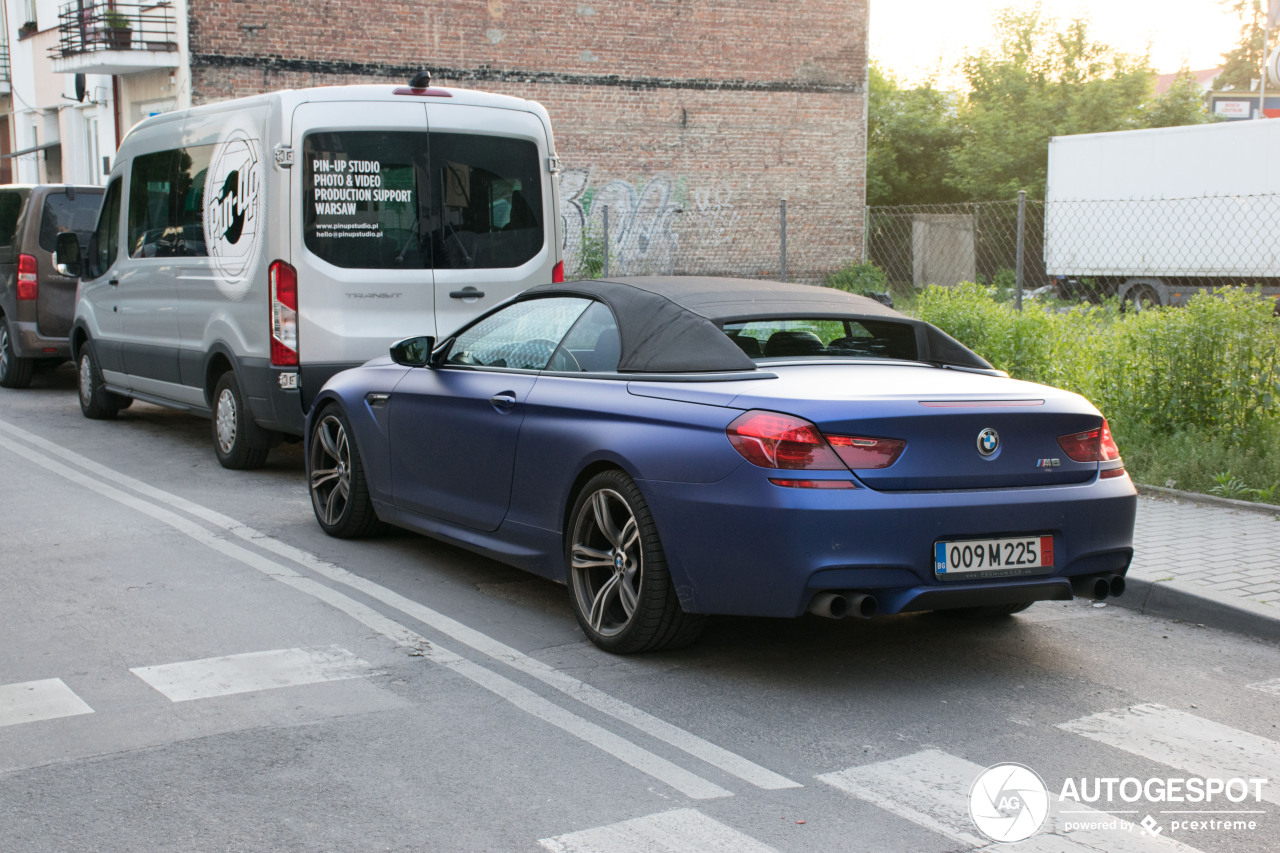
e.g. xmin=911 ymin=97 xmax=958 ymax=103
xmin=564 ymin=470 xmax=705 ymax=654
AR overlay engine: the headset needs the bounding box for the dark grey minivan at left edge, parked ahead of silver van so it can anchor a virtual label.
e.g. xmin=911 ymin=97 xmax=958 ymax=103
xmin=0 ymin=183 xmax=102 ymax=388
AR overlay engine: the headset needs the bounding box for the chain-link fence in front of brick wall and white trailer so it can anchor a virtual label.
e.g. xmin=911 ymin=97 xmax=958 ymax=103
xmin=561 ymin=189 xmax=1280 ymax=305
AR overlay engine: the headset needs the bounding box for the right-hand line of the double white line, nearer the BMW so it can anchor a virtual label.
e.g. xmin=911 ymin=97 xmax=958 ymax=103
xmin=0 ymin=420 xmax=803 ymax=790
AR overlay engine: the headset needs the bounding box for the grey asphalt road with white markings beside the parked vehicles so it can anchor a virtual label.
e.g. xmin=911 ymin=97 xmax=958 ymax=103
xmin=0 ymin=369 xmax=1280 ymax=853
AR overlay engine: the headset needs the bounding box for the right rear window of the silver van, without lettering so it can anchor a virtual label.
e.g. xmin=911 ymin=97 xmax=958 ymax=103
xmin=429 ymin=133 xmax=544 ymax=269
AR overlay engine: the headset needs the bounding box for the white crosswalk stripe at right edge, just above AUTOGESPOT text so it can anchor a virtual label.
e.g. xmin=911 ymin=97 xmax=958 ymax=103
xmin=1059 ymin=704 xmax=1280 ymax=808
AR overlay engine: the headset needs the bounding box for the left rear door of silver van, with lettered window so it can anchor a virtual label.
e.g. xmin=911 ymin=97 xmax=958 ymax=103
xmin=290 ymin=100 xmax=435 ymax=399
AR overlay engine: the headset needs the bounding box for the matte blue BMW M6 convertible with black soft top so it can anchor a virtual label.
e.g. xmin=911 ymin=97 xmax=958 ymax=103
xmin=306 ymin=277 xmax=1137 ymax=653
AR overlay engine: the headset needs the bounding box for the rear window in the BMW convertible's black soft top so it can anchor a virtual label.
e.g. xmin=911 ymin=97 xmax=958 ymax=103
xmin=723 ymin=319 xmax=919 ymax=361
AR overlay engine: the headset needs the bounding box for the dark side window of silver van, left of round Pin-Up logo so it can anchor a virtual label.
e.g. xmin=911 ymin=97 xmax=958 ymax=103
xmin=128 ymin=145 xmax=214 ymax=257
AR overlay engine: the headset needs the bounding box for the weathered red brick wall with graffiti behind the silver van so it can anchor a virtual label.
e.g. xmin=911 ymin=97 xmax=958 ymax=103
xmin=189 ymin=0 xmax=868 ymax=278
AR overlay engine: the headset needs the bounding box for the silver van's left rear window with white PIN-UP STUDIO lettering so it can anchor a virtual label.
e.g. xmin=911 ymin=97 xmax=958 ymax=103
xmin=302 ymin=131 xmax=431 ymax=269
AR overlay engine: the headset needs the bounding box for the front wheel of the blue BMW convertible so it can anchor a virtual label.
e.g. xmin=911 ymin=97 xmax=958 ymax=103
xmin=307 ymin=406 xmax=381 ymax=539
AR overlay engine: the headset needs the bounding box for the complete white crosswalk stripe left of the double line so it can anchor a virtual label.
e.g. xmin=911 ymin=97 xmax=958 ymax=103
xmin=129 ymin=646 xmax=374 ymax=702
